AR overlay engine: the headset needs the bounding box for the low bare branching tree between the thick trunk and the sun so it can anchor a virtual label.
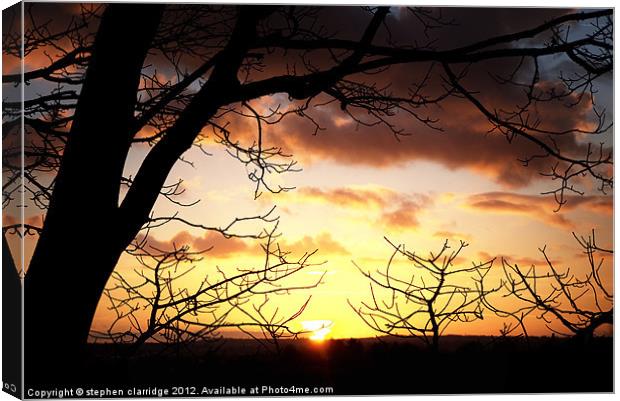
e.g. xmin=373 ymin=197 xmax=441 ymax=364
xmin=91 ymin=229 xmax=324 ymax=355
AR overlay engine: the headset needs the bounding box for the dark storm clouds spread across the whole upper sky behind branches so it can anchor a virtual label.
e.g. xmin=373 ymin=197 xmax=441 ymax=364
xmin=17 ymin=3 xmax=608 ymax=191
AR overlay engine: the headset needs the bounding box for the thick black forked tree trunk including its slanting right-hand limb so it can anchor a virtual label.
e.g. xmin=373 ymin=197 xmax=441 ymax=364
xmin=25 ymin=5 xmax=267 ymax=384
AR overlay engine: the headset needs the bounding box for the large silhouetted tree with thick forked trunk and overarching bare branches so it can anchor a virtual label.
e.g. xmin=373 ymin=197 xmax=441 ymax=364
xmin=3 ymin=4 xmax=613 ymax=380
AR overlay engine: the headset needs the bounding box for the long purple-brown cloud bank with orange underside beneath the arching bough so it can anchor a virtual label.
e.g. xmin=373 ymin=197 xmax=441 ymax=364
xmin=251 ymin=84 xmax=591 ymax=188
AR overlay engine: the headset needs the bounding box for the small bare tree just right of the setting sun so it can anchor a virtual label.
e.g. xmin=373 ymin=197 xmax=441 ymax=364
xmin=349 ymin=238 xmax=497 ymax=352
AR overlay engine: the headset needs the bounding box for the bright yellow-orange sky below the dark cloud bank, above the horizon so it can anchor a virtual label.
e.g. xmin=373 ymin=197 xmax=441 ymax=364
xmin=89 ymin=107 xmax=612 ymax=338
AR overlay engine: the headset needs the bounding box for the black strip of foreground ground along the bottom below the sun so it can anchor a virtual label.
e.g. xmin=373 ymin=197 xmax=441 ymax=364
xmin=26 ymin=337 xmax=613 ymax=396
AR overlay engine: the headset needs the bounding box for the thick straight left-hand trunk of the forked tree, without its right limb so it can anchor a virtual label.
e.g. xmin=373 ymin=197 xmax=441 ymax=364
xmin=24 ymin=4 xmax=162 ymax=383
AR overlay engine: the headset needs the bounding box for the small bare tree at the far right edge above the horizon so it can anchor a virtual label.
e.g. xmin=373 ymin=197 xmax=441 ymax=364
xmin=485 ymin=230 xmax=613 ymax=343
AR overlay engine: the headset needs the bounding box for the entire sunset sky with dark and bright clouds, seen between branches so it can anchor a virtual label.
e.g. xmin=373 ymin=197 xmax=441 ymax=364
xmin=4 ymin=2 xmax=613 ymax=338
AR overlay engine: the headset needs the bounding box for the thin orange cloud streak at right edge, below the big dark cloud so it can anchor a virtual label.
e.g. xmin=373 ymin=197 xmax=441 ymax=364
xmin=466 ymin=192 xmax=613 ymax=228
